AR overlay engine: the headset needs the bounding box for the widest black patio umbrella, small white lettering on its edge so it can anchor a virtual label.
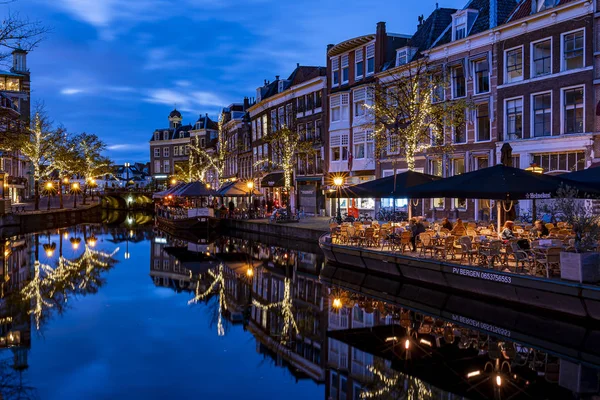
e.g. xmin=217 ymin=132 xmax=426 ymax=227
xmin=407 ymin=164 xmax=600 ymax=201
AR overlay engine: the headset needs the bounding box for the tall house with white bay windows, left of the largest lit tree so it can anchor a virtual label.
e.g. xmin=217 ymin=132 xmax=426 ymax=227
xmin=325 ymin=22 xmax=410 ymax=216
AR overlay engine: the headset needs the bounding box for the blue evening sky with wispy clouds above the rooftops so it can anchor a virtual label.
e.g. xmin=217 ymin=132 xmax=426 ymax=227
xmin=7 ymin=0 xmax=466 ymax=163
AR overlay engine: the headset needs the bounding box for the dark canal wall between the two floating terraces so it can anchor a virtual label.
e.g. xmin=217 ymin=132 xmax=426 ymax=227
xmin=221 ymin=219 xmax=326 ymax=243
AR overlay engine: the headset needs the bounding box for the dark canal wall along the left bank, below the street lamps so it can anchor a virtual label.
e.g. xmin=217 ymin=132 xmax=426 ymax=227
xmin=0 ymin=204 xmax=102 ymax=237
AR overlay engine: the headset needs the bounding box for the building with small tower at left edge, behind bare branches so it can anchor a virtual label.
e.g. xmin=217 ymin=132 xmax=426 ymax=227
xmin=0 ymin=48 xmax=33 ymax=206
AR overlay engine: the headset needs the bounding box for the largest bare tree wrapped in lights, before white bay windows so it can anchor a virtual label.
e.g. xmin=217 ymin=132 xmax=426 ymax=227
xmin=365 ymin=60 xmax=468 ymax=170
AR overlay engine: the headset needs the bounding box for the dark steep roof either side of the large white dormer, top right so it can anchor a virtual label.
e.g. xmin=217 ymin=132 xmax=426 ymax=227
xmin=434 ymin=0 xmax=517 ymax=46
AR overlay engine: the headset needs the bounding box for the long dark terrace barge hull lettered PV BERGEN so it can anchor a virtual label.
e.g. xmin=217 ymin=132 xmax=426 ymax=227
xmin=319 ymin=234 xmax=600 ymax=320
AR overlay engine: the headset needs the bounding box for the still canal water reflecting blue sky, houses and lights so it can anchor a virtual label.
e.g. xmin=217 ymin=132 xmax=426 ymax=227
xmin=0 ymin=211 xmax=600 ymax=400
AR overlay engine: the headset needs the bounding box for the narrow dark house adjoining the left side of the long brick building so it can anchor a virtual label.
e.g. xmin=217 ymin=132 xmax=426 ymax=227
xmin=220 ymin=97 xmax=252 ymax=180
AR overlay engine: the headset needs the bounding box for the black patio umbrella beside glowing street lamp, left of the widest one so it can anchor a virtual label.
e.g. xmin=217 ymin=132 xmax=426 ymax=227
xmin=327 ymin=171 xmax=441 ymax=199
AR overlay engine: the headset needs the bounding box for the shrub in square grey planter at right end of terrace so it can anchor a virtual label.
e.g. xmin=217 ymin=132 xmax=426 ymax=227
xmin=555 ymin=186 xmax=600 ymax=283
